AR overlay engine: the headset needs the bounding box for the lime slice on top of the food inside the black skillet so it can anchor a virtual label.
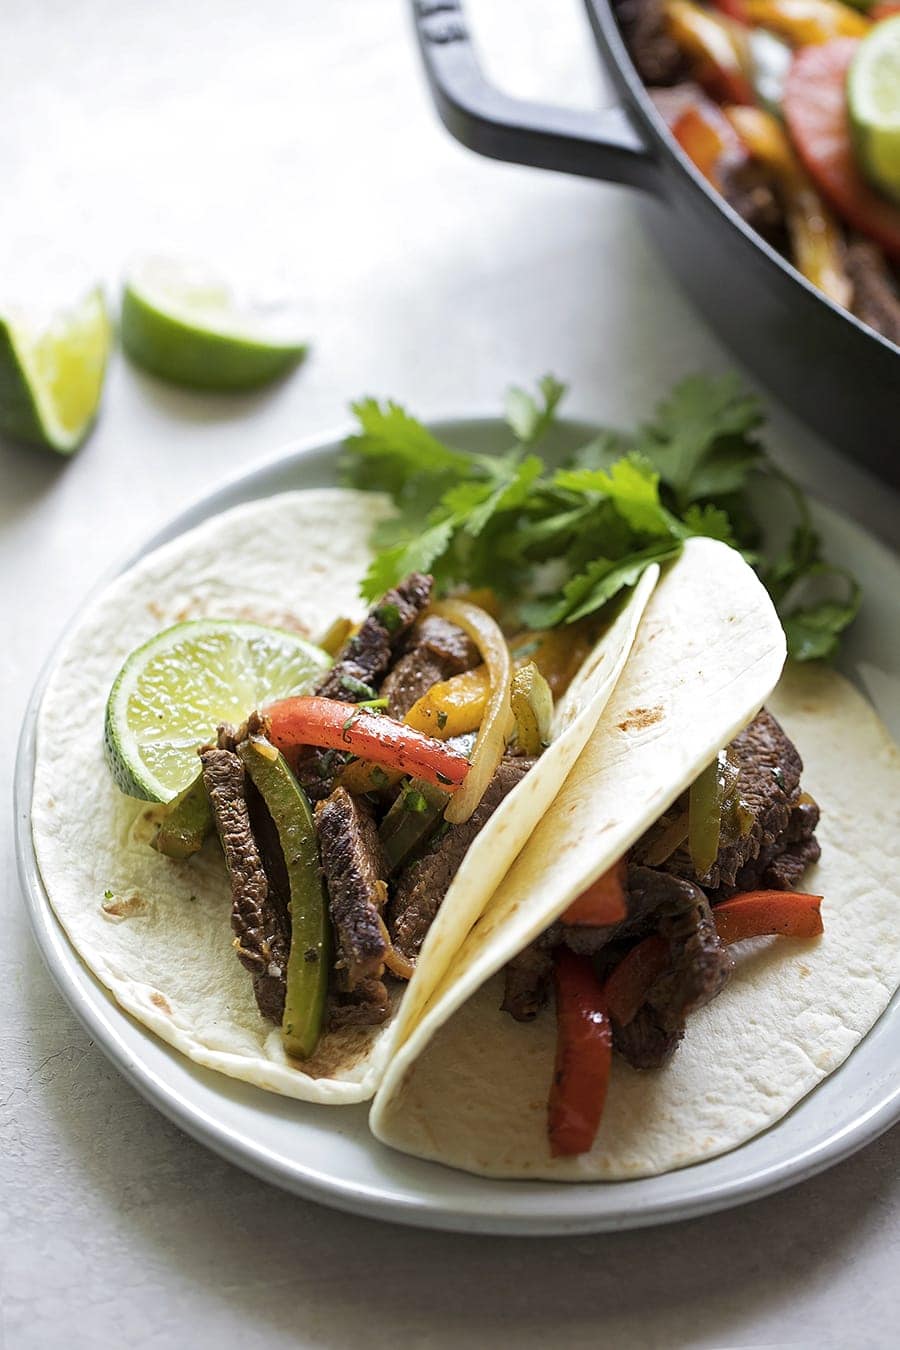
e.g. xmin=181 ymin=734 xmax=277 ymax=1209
xmin=847 ymin=15 xmax=900 ymax=201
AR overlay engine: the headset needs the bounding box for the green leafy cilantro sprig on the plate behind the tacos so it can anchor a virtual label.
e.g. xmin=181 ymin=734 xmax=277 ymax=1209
xmin=343 ymin=375 xmax=860 ymax=660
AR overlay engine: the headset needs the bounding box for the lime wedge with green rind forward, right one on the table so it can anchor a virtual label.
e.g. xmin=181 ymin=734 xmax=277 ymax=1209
xmin=121 ymin=258 xmax=306 ymax=390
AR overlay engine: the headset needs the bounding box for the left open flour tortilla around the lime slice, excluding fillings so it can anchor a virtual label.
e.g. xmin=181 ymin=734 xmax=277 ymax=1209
xmin=32 ymin=489 xmax=658 ymax=1103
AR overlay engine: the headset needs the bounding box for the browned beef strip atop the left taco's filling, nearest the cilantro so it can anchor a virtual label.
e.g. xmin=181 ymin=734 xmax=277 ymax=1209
xmin=316 ymin=572 xmax=432 ymax=703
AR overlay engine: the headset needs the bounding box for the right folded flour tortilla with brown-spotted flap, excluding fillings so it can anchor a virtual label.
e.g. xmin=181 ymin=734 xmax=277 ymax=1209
xmin=371 ymin=541 xmax=900 ymax=1181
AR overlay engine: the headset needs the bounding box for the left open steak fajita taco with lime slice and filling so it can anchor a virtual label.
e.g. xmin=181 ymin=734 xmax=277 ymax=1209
xmin=32 ymin=489 xmax=669 ymax=1103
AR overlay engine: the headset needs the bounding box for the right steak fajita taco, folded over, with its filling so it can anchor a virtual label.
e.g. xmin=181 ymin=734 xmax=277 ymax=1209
xmin=371 ymin=541 xmax=900 ymax=1181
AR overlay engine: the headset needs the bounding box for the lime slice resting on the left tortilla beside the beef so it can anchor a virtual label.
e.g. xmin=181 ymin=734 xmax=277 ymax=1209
xmin=105 ymin=618 xmax=331 ymax=802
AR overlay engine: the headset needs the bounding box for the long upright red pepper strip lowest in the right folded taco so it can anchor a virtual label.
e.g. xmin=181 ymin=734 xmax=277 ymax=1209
xmin=548 ymin=946 xmax=613 ymax=1158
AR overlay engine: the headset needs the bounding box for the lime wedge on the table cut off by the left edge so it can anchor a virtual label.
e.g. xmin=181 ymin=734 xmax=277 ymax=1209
xmin=0 ymin=288 xmax=112 ymax=455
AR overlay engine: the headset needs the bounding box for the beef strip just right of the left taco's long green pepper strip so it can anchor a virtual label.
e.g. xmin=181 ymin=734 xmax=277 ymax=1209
xmin=314 ymin=787 xmax=387 ymax=992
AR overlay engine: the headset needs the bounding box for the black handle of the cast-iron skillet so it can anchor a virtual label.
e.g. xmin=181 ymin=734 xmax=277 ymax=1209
xmin=413 ymin=0 xmax=660 ymax=192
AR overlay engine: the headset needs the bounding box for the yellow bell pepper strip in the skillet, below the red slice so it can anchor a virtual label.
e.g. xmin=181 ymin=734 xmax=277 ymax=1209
xmin=726 ymin=108 xmax=853 ymax=308
